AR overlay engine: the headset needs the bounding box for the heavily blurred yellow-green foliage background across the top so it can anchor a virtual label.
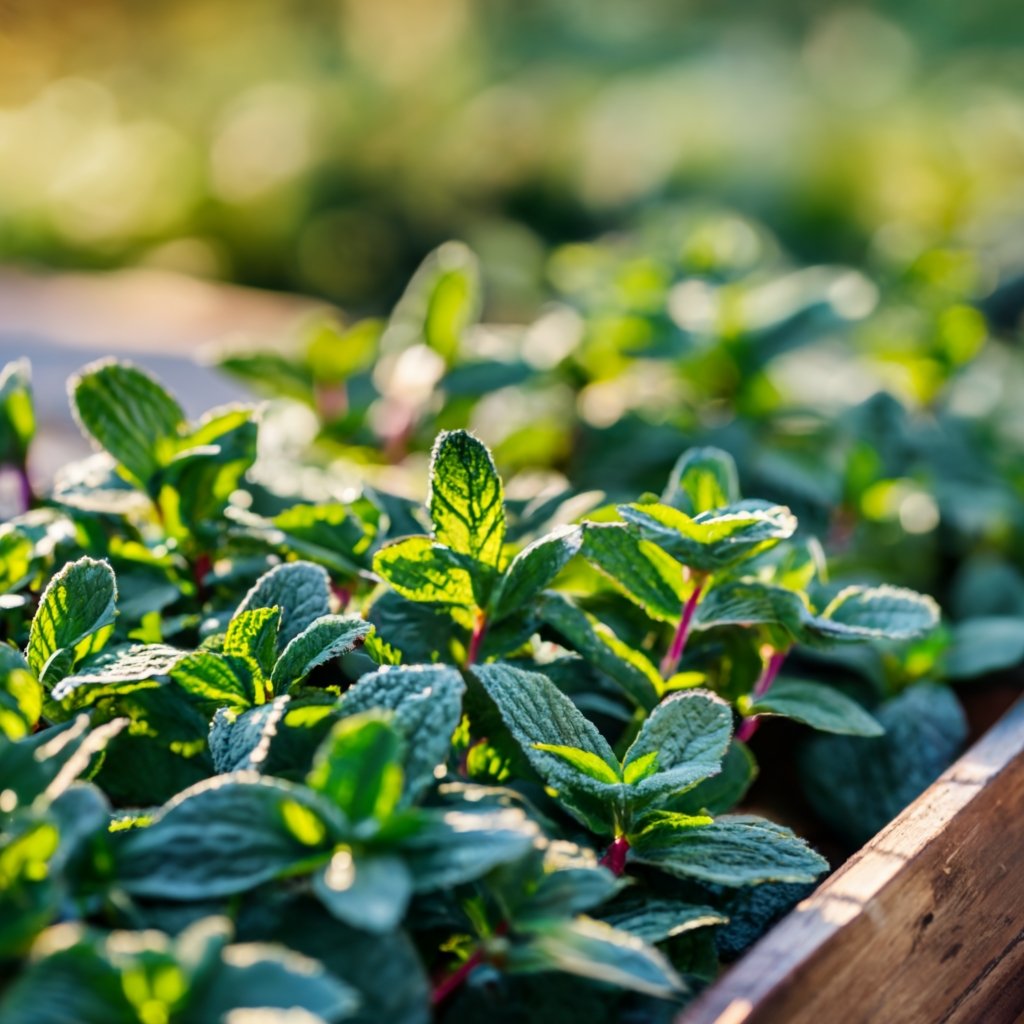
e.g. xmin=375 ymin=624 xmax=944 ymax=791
xmin=6 ymin=0 xmax=1024 ymax=318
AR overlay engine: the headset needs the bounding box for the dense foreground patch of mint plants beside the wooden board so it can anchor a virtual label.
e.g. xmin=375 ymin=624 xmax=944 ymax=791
xmin=0 ymin=354 xmax=995 ymax=1024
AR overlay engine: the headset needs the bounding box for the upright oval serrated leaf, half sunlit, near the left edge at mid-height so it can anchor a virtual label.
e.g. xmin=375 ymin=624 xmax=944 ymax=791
xmin=26 ymin=558 xmax=118 ymax=687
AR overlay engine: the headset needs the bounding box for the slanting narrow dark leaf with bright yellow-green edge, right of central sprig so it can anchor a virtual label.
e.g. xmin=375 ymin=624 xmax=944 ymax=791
xmin=535 ymin=593 xmax=663 ymax=711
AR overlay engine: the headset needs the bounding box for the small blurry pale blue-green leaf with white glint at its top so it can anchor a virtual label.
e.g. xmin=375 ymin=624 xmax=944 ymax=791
xmin=313 ymin=849 xmax=413 ymax=935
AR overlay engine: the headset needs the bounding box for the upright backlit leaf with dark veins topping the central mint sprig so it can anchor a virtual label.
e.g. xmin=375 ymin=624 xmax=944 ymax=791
xmin=427 ymin=430 xmax=505 ymax=568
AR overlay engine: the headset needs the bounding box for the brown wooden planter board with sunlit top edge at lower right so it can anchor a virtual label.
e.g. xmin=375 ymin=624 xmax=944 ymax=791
xmin=677 ymin=701 xmax=1024 ymax=1024
